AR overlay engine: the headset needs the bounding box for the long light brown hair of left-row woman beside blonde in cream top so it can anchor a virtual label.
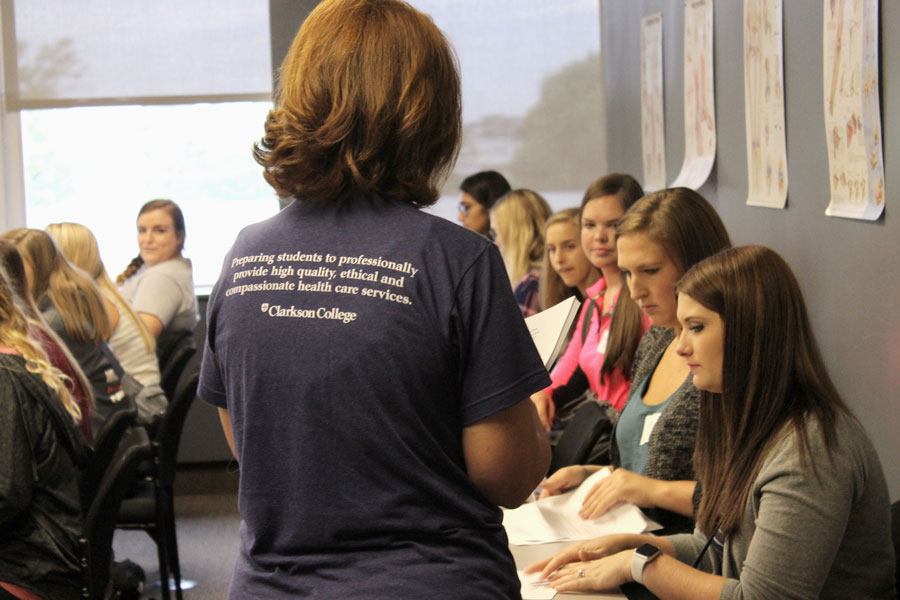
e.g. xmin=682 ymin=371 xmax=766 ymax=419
xmin=2 ymin=228 xmax=112 ymax=343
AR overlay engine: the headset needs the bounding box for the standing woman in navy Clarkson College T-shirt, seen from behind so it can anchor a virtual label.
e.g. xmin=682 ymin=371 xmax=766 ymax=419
xmin=199 ymin=0 xmax=550 ymax=600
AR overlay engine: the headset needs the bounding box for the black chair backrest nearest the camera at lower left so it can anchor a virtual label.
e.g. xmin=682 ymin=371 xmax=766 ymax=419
xmin=79 ymin=427 xmax=153 ymax=600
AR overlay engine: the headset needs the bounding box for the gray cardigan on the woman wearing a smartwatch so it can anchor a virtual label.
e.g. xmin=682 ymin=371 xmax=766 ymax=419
xmin=668 ymin=417 xmax=896 ymax=600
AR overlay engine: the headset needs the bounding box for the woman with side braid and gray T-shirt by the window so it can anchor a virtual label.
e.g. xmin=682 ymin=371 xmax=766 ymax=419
xmin=116 ymin=200 xmax=200 ymax=356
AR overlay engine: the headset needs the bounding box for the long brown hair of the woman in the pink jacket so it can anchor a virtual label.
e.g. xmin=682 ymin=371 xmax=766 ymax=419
xmin=579 ymin=173 xmax=644 ymax=382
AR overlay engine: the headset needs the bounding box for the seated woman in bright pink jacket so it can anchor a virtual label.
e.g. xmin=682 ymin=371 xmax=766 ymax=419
xmin=531 ymin=173 xmax=649 ymax=430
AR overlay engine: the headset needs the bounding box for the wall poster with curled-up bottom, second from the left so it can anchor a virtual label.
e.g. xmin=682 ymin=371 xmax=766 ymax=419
xmin=672 ymin=0 xmax=716 ymax=190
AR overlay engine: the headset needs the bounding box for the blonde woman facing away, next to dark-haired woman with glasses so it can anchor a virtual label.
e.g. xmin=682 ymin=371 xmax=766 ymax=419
xmin=491 ymin=189 xmax=552 ymax=317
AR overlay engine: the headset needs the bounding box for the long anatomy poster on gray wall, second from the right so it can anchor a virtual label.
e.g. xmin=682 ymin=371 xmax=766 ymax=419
xmin=744 ymin=0 xmax=788 ymax=208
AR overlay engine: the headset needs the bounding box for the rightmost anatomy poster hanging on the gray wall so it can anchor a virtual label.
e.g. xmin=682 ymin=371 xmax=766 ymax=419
xmin=823 ymin=0 xmax=884 ymax=221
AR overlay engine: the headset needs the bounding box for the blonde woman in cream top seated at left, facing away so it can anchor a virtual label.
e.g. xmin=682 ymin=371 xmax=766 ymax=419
xmin=47 ymin=223 xmax=159 ymax=386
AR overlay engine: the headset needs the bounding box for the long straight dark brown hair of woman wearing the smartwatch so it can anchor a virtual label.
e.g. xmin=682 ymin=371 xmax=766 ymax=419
xmin=678 ymin=246 xmax=849 ymax=535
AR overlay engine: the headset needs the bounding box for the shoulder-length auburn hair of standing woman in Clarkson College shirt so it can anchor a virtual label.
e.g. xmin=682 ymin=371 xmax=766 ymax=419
xmin=254 ymin=0 xmax=461 ymax=207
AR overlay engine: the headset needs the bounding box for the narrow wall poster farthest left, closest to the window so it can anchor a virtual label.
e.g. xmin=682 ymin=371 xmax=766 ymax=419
xmin=641 ymin=13 xmax=666 ymax=192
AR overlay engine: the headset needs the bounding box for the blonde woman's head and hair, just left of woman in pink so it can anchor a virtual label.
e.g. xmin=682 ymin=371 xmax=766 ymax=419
xmin=540 ymin=208 xmax=600 ymax=308
